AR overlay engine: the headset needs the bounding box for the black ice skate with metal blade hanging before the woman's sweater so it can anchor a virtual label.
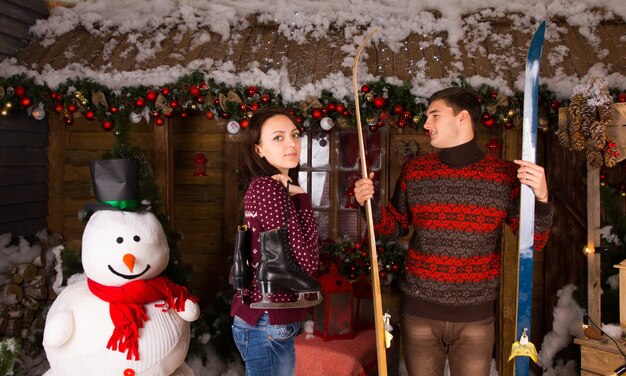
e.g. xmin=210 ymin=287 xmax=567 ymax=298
xmin=256 ymin=228 xmax=321 ymax=295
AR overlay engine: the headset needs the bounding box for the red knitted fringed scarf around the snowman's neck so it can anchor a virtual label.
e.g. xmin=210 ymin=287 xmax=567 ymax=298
xmin=87 ymin=277 xmax=198 ymax=360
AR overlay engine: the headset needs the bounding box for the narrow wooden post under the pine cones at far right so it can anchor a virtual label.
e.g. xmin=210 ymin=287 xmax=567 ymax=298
xmin=585 ymin=168 xmax=602 ymax=325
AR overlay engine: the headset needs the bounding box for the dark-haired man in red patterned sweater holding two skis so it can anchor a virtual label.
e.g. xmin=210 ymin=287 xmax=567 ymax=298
xmin=354 ymin=87 xmax=552 ymax=376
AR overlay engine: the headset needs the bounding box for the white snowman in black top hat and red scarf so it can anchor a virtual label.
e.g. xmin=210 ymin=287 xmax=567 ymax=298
xmin=43 ymin=159 xmax=200 ymax=376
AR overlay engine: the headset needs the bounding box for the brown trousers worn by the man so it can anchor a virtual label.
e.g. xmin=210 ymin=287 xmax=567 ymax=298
xmin=402 ymin=313 xmax=495 ymax=376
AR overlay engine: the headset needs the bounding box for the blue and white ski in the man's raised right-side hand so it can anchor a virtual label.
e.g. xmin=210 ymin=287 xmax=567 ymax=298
xmin=509 ymin=21 xmax=546 ymax=376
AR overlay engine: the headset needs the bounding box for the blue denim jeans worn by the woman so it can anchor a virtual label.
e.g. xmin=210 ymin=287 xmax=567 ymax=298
xmin=233 ymin=313 xmax=300 ymax=376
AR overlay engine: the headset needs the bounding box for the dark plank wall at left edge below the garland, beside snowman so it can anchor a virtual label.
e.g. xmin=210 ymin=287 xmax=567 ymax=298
xmin=0 ymin=113 xmax=48 ymax=238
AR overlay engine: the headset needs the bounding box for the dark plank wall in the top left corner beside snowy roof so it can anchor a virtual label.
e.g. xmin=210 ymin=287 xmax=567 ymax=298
xmin=0 ymin=0 xmax=48 ymax=60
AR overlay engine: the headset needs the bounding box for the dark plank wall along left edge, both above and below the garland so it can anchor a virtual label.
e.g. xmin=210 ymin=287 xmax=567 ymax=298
xmin=0 ymin=0 xmax=48 ymax=238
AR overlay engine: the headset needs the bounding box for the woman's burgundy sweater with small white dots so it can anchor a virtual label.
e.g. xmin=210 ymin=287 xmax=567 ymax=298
xmin=230 ymin=176 xmax=319 ymax=325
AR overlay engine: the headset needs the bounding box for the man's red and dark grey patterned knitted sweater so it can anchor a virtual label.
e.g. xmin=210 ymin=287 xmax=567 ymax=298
xmin=374 ymin=141 xmax=552 ymax=322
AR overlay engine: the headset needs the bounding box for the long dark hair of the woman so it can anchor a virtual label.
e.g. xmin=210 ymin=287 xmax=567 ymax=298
xmin=243 ymin=107 xmax=300 ymax=185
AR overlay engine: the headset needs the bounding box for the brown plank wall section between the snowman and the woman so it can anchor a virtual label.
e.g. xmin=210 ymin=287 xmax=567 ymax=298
xmin=169 ymin=115 xmax=229 ymax=303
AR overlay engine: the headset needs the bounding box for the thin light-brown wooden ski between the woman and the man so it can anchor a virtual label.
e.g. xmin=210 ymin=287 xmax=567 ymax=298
xmin=352 ymin=29 xmax=387 ymax=376
